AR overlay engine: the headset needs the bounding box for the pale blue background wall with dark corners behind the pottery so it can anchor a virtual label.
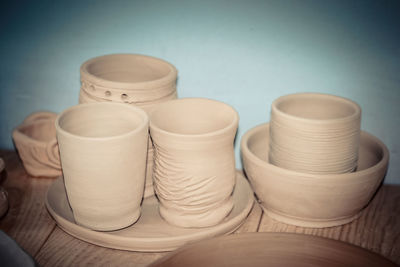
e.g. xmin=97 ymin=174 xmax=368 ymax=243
xmin=0 ymin=0 xmax=400 ymax=184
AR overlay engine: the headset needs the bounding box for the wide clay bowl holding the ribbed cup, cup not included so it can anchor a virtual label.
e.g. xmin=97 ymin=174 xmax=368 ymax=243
xmin=241 ymin=123 xmax=389 ymax=227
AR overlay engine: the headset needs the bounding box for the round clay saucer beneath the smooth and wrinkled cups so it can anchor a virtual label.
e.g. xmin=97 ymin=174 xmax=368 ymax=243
xmin=46 ymin=172 xmax=254 ymax=252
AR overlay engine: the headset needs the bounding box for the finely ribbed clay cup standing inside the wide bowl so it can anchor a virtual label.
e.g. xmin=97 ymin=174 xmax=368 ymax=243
xmin=269 ymin=93 xmax=361 ymax=174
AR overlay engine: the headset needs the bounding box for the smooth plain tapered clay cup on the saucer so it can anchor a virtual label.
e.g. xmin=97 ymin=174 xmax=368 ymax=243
xmin=56 ymin=103 xmax=148 ymax=231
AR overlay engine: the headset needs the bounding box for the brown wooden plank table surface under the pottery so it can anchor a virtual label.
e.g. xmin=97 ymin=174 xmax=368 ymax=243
xmin=0 ymin=151 xmax=400 ymax=266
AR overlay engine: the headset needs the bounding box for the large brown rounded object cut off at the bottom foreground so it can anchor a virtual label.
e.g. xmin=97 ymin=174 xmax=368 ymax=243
xmin=150 ymin=233 xmax=396 ymax=267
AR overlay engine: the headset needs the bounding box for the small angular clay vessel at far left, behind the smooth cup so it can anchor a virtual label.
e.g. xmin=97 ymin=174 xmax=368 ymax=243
xmin=12 ymin=112 xmax=61 ymax=177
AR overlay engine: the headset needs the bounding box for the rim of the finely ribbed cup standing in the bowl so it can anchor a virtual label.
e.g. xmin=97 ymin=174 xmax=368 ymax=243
xmin=271 ymin=92 xmax=361 ymax=124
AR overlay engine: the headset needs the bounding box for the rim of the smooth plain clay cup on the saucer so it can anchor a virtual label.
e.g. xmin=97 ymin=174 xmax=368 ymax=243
xmin=55 ymin=102 xmax=149 ymax=141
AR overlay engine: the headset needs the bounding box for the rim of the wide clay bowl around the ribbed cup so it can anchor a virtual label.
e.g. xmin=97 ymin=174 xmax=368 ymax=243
xmin=240 ymin=123 xmax=389 ymax=181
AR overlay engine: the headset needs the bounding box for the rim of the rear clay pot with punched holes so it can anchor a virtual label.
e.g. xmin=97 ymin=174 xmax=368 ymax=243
xmin=80 ymin=53 xmax=178 ymax=90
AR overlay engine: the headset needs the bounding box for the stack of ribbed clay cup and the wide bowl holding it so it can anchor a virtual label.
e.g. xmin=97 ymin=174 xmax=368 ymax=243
xmin=241 ymin=93 xmax=389 ymax=228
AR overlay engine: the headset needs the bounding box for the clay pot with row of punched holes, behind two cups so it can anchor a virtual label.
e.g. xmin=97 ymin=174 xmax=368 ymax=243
xmin=79 ymin=54 xmax=177 ymax=197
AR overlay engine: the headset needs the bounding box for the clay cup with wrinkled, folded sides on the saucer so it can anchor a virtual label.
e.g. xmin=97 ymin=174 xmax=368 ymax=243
xmin=150 ymin=98 xmax=239 ymax=227
